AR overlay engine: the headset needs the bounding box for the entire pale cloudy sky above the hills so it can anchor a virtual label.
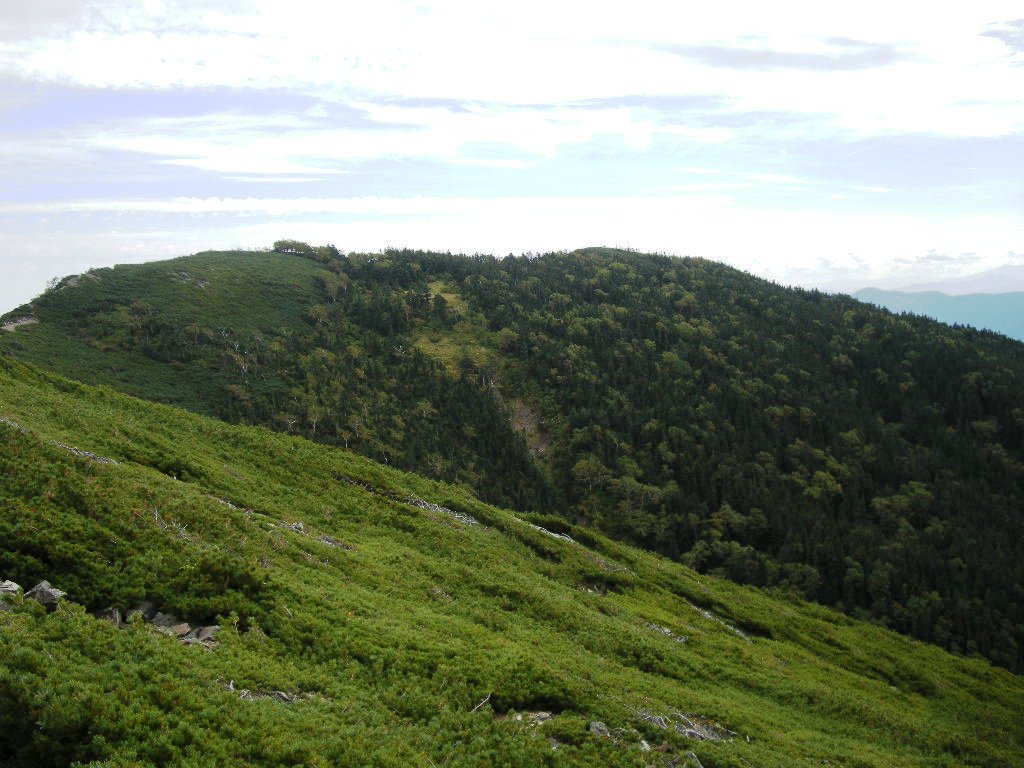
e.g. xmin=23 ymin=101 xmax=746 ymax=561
xmin=0 ymin=0 xmax=1024 ymax=311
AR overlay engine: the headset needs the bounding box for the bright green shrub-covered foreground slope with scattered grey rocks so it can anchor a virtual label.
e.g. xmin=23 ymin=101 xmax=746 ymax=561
xmin=0 ymin=357 xmax=1024 ymax=768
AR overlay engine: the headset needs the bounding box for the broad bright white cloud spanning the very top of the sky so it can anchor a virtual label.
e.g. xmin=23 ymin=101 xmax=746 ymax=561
xmin=0 ymin=0 xmax=1024 ymax=141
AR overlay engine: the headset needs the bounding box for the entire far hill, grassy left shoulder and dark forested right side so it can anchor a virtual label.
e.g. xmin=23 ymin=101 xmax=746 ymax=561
xmin=6 ymin=244 xmax=1024 ymax=670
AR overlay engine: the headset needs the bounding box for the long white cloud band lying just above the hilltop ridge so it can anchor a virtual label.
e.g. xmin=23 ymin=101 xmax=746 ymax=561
xmin=6 ymin=195 xmax=1024 ymax=283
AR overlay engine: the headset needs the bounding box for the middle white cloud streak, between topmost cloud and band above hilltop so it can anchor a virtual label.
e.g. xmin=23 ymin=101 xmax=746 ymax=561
xmin=51 ymin=102 xmax=731 ymax=175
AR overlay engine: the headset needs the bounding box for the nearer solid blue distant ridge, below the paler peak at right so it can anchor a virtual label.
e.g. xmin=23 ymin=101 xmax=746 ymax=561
xmin=853 ymin=288 xmax=1024 ymax=341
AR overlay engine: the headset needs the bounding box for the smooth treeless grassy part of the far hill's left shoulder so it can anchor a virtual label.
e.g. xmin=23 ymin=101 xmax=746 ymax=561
xmin=0 ymin=251 xmax=323 ymax=414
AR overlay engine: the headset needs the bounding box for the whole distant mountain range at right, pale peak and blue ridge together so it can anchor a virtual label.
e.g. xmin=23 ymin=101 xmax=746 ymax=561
xmin=854 ymin=265 xmax=1024 ymax=341
